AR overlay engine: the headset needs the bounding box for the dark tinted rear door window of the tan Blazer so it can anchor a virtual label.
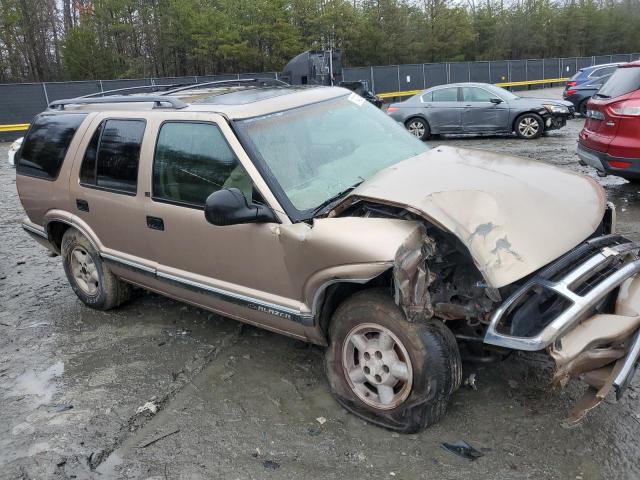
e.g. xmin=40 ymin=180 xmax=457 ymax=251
xmin=80 ymin=119 xmax=145 ymax=194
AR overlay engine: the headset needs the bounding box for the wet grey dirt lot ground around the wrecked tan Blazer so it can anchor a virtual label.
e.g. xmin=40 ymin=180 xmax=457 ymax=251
xmin=0 ymin=91 xmax=640 ymax=479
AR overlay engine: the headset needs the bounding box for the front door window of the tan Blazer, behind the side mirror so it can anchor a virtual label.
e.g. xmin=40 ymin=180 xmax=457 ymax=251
xmin=153 ymin=122 xmax=253 ymax=207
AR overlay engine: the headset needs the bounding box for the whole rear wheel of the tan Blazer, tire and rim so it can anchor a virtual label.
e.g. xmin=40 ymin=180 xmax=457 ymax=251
xmin=61 ymin=228 xmax=131 ymax=310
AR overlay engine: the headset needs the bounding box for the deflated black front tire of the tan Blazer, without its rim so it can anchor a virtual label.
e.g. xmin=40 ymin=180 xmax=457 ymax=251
xmin=325 ymin=289 xmax=462 ymax=433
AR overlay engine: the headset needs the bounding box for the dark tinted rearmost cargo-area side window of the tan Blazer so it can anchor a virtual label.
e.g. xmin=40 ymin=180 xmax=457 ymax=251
xmin=17 ymin=113 xmax=87 ymax=180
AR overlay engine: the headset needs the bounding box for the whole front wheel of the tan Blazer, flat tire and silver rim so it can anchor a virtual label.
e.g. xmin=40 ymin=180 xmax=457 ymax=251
xmin=325 ymin=289 xmax=462 ymax=433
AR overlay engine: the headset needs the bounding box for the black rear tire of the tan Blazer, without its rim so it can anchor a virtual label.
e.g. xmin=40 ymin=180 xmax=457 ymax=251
xmin=61 ymin=228 xmax=131 ymax=310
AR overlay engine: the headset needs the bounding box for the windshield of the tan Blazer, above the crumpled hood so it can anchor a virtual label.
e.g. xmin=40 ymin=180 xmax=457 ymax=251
xmin=238 ymin=94 xmax=429 ymax=217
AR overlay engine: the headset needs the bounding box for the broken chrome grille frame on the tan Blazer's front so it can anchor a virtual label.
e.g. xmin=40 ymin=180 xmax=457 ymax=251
xmin=484 ymin=236 xmax=640 ymax=351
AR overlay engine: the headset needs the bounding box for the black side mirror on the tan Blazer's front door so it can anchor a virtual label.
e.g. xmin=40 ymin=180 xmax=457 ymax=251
xmin=204 ymin=188 xmax=280 ymax=227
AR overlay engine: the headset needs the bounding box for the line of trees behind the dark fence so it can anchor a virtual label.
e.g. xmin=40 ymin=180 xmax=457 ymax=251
xmin=0 ymin=0 xmax=640 ymax=82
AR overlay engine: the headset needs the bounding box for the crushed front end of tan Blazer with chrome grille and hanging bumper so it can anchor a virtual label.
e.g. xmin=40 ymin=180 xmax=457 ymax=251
xmin=484 ymin=235 xmax=640 ymax=422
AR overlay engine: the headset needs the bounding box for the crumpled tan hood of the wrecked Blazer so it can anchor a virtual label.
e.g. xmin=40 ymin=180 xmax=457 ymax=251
xmin=347 ymin=146 xmax=606 ymax=288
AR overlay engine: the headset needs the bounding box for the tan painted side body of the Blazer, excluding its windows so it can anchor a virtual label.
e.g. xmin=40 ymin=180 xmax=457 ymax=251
xmin=19 ymin=110 xmax=419 ymax=343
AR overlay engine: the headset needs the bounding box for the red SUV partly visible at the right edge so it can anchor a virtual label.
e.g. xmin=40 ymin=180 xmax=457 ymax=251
xmin=578 ymin=61 xmax=640 ymax=182
